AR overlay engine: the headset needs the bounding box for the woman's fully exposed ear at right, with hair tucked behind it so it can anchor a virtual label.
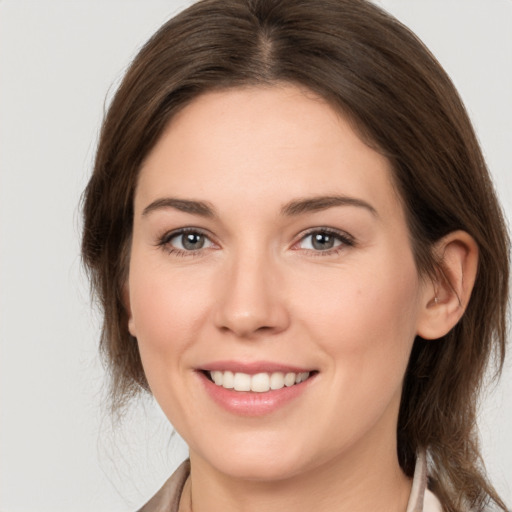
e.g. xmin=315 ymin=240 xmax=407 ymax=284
xmin=417 ymin=231 xmax=478 ymax=339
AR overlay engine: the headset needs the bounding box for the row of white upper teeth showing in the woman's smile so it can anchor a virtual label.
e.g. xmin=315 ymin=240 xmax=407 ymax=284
xmin=210 ymin=371 xmax=309 ymax=393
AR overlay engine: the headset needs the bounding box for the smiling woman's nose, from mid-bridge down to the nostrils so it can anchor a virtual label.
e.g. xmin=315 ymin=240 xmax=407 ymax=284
xmin=215 ymin=250 xmax=290 ymax=339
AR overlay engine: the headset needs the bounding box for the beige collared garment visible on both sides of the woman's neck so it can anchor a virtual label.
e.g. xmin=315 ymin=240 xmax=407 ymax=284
xmin=138 ymin=452 xmax=443 ymax=512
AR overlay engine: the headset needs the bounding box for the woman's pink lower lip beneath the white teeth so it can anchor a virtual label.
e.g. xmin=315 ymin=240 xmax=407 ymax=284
xmin=197 ymin=372 xmax=315 ymax=416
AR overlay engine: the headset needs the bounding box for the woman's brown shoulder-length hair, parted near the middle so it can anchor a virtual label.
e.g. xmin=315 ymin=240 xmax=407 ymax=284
xmin=83 ymin=0 xmax=509 ymax=511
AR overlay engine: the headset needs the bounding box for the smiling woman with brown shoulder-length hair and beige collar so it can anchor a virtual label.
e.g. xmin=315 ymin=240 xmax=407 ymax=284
xmin=83 ymin=0 xmax=508 ymax=512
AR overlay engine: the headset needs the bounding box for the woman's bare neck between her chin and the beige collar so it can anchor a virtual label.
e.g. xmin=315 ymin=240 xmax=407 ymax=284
xmin=185 ymin=432 xmax=411 ymax=512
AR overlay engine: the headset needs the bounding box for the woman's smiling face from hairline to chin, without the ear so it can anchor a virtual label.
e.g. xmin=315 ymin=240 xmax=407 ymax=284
xmin=126 ymin=86 xmax=426 ymax=480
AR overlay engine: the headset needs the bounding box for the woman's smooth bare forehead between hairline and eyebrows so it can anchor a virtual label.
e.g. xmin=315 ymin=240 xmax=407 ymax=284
xmin=136 ymin=85 xmax=397 ymax=218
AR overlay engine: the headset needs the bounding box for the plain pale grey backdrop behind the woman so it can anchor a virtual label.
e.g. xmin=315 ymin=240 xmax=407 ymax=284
xmin=0 ymin=0 xmax=512 ymax=512
